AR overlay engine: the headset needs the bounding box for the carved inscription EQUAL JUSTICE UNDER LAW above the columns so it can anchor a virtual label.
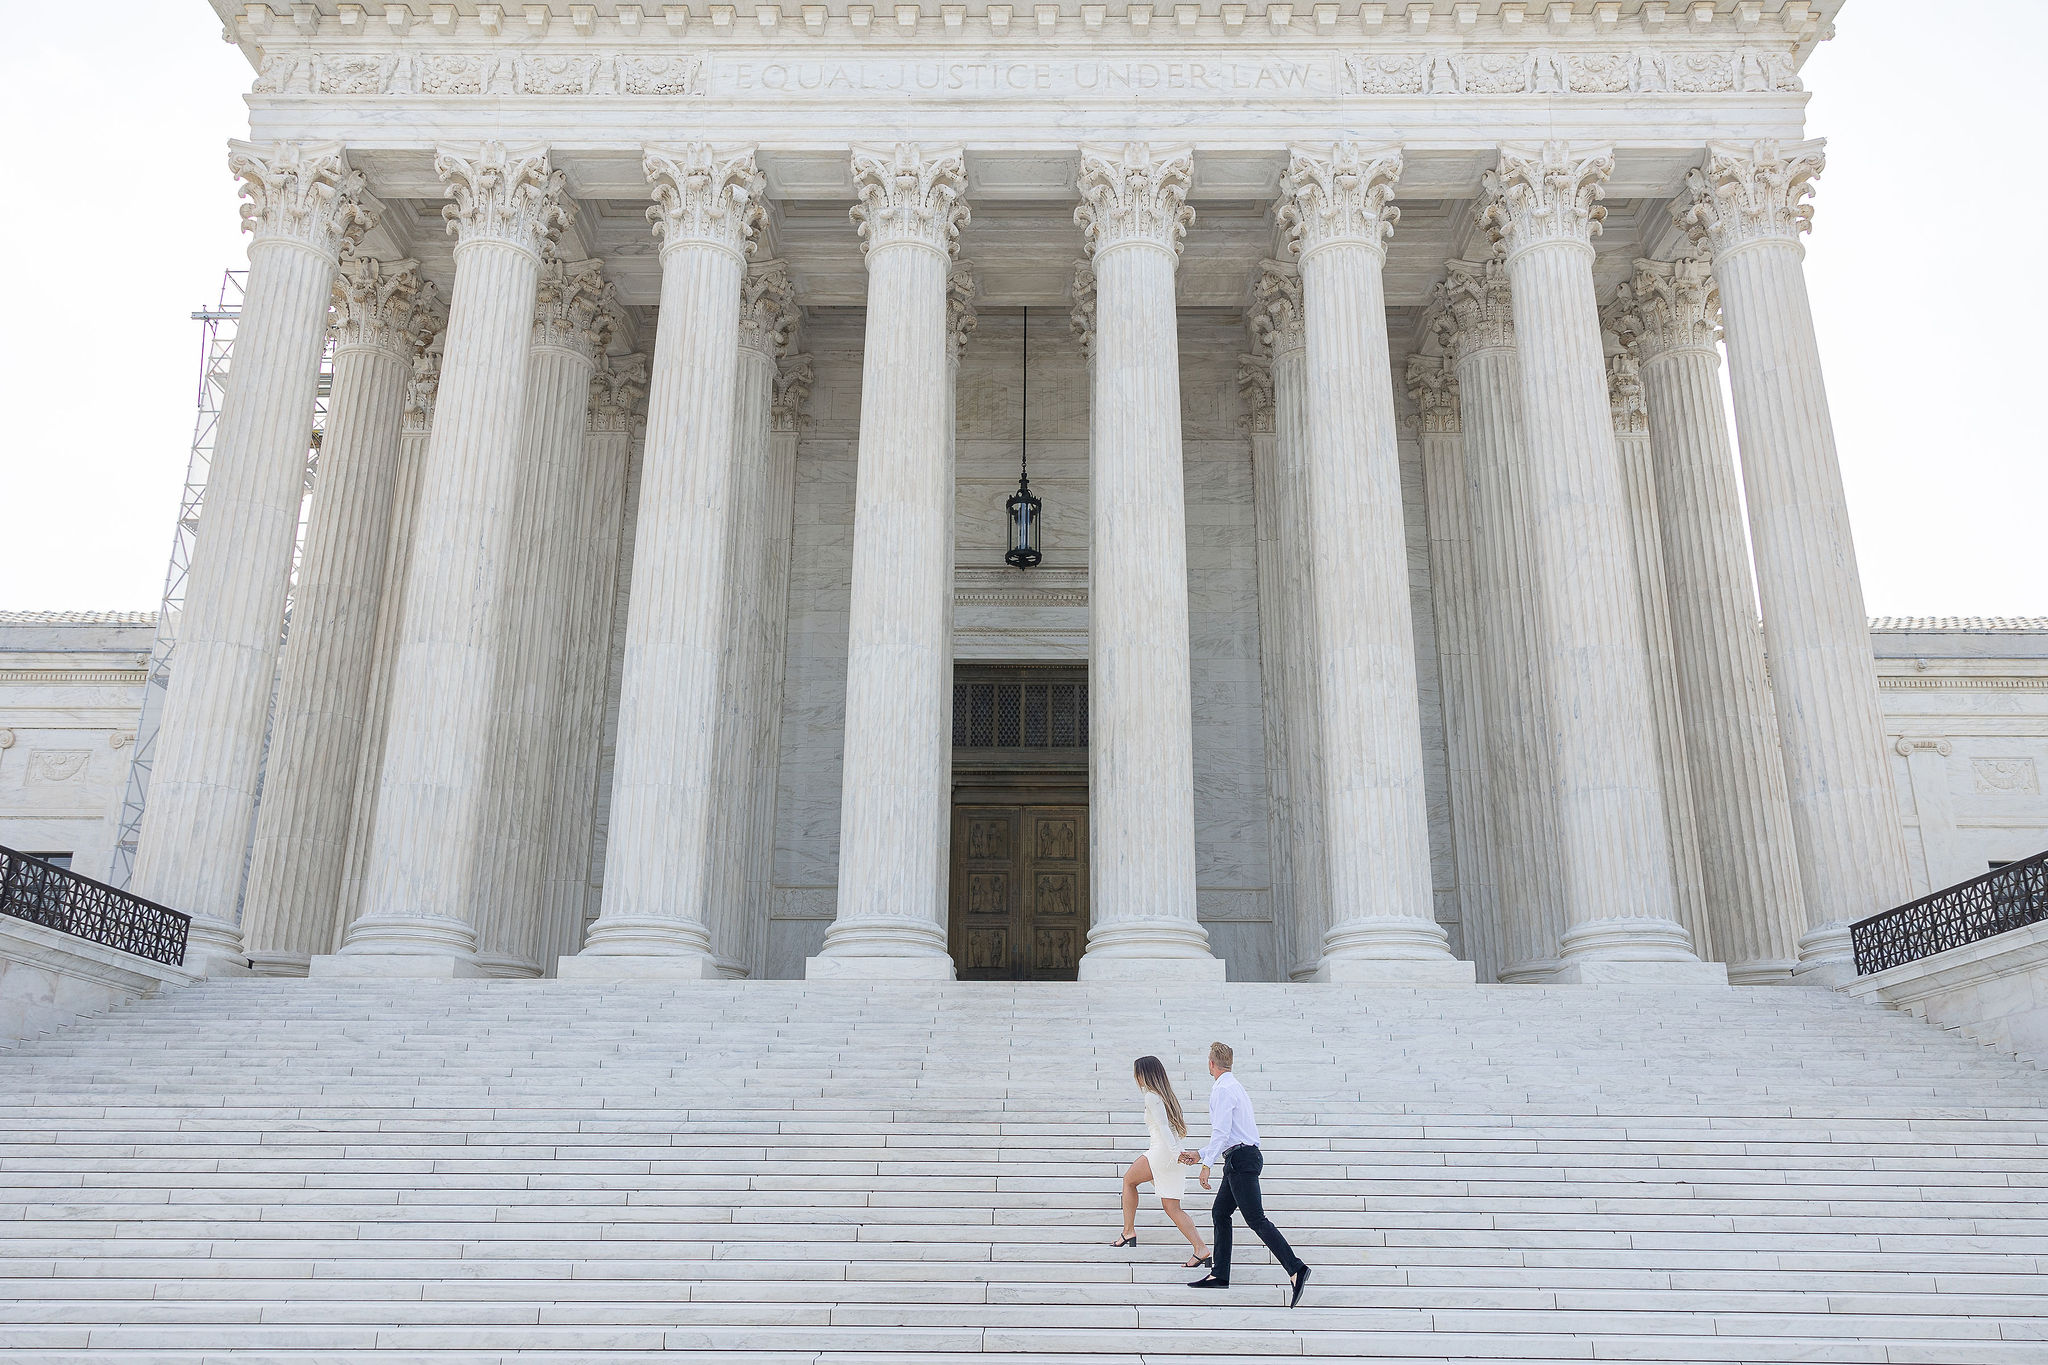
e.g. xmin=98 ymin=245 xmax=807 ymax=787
xmin=709 ymin=59 xmax=1335 ymax=96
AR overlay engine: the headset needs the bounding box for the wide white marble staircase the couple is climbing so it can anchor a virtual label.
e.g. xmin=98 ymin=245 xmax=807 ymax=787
xmin=0 ymin=980 xmax=2048 ymax=1365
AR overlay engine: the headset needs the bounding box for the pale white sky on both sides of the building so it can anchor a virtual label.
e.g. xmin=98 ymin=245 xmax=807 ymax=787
xmin=0 ymin=0 xmax=2048 ymax=616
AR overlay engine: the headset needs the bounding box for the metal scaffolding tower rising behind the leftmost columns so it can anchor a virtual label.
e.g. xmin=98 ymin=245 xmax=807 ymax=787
xmin=106 ymin=270 xmax=334 ymax=886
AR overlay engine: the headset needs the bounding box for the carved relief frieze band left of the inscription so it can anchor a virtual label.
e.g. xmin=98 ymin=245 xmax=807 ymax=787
xmin=252 ymin=49 xmax=705 ymax=98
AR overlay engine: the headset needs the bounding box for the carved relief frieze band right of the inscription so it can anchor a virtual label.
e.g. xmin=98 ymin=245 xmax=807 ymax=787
xmin=1339 ymin=47 xmax=1804 ymax=96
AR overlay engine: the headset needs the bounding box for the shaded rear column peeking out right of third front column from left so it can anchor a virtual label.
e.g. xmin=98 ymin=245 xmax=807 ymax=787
xmin=711 ymin=260 xmax=801 ymax=976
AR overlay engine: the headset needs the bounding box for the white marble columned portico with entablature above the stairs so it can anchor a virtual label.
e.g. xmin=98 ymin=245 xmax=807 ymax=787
xmin=133 ymin=0 xmax=1913 ymax=986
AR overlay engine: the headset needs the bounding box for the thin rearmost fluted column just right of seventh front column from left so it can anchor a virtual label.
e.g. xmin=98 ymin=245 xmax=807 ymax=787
xmin=1604 ymin=335 xmax=1716 ymax=962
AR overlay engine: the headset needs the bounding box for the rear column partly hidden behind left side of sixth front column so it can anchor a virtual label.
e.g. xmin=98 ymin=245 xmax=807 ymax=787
xmin=1245 ymin=260 xmax=1329 ymax=980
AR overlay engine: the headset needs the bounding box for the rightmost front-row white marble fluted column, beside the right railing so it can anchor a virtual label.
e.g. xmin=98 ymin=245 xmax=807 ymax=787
xmin=1675 ymin=141 xmax=1913 ymax=984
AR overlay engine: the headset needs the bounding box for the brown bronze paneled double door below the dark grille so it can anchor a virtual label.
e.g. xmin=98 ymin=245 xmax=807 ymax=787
xmin=950 ymin=806 xmax=1087 ymax=980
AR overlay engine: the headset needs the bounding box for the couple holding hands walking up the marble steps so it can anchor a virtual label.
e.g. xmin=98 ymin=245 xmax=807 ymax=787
xmin=1112 ymin=1044 xmax=1309 ymax=1308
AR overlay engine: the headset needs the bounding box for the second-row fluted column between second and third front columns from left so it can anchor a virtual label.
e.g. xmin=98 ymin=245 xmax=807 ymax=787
xmin=469 ymin=258 xmax=625 ymax=976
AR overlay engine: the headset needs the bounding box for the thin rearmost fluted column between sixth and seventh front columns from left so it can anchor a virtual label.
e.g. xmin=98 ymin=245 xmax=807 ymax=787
xmin=1407 ymin=341 xmax=1501 ymax=980
